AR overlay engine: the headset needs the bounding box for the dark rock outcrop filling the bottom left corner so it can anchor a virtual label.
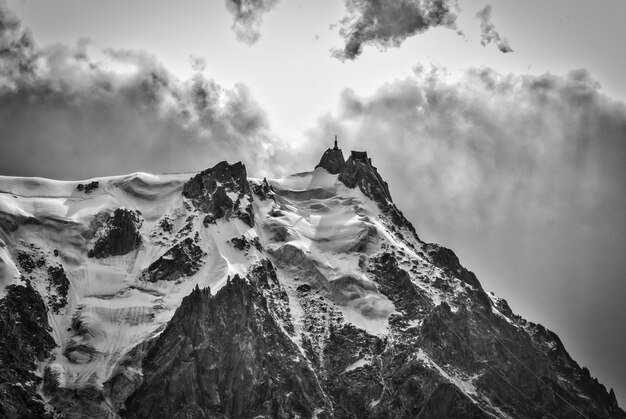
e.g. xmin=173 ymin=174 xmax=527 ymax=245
xmin=0 ymin=283 xmax=55 ymax=418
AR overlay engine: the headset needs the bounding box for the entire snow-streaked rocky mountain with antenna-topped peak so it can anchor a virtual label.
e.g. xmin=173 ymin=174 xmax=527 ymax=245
xmin=0 ymin=148 xmax=626 ymax=419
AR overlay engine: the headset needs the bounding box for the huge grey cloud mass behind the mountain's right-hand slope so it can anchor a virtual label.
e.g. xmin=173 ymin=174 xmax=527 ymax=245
xmin=310 ymin=65 xmax=626 ymax=404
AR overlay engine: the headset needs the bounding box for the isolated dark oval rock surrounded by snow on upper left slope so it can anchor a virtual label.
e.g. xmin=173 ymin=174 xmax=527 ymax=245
xmin=87 ymin=208 xmax=143 ymax=259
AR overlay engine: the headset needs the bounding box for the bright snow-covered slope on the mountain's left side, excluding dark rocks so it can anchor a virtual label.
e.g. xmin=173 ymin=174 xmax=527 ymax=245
xmin=0 ymin=173 xmax=258 ymax=387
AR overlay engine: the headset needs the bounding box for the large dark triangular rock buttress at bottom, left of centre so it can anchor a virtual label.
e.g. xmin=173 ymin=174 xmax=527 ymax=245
xmin=122 ymin=263 xmax=329 ymax=418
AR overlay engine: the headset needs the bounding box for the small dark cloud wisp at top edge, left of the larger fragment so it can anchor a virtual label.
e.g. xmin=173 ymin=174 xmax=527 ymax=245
xmin=225 ymin=0 xmax=278 ymax=44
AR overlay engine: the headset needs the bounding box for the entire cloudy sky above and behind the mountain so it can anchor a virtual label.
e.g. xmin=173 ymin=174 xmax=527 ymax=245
xmin=0 ymin=0 xmax=626 ymax=407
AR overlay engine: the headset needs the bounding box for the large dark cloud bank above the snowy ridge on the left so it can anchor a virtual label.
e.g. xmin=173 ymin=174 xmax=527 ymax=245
xmin=0 ymin=3 xmax=285 ymax=178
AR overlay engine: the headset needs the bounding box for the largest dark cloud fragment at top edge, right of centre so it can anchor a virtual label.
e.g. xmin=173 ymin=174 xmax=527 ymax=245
xmin=333 ymin=0 xmax=456 ymax=60
